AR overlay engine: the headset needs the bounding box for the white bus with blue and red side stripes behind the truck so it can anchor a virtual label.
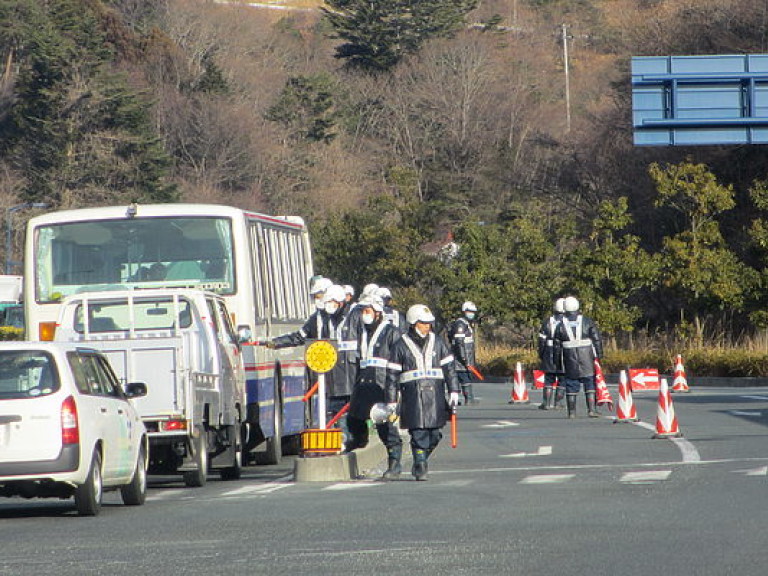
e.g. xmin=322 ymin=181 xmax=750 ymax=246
xmin=24 ymin=204 xmax=313 ymax=463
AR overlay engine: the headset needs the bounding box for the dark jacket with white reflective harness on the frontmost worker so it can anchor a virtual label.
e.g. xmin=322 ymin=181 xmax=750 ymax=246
xmin=386 ymin=329 xmax=459 ymax=430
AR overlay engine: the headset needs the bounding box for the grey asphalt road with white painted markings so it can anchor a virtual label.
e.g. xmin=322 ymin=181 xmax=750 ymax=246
xmin=0 ymin=384 xmax=768 ymax=576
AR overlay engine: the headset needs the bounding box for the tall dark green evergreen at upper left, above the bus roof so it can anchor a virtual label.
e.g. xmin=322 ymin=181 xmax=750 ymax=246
xmin=0 ymin=0 xmax=175 ymax=206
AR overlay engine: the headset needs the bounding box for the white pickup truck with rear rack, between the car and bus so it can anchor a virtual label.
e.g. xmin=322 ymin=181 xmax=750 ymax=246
xmin=55 ymin=288 xmax=246 ymax=486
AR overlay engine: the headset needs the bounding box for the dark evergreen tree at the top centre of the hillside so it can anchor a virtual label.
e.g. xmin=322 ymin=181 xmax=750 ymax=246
xmin=323 ymin=0 xmax=478 ymax=72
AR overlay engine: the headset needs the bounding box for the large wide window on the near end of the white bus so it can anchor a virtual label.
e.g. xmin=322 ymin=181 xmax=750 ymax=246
xmin=34 ymin=216 xmax=235 ymax=303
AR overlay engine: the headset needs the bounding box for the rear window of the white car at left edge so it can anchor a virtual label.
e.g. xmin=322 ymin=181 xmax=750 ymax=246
xmin=0 ymin=350 xmax=59 ymax=400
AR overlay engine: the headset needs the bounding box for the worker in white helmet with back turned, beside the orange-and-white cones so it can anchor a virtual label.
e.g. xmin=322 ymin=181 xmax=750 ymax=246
xmin=555 ymin=296 xmax=603 ymax=418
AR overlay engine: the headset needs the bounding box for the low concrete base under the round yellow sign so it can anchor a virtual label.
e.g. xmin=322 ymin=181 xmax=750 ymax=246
xmin=293 ymin=434 xmax=387 ymax=482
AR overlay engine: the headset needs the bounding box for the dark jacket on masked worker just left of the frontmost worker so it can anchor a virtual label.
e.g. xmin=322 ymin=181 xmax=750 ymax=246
xmin=349 ymin=319 xmax=401 ymax=420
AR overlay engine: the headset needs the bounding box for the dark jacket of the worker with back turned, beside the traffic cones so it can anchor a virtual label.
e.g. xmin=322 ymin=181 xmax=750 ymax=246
xmin=555 ymin=312 xmax=603 ymax=378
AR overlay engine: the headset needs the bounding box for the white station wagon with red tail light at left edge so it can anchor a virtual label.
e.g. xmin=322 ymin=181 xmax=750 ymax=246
xmin=0 ymin=342 xmax=148 ymax=516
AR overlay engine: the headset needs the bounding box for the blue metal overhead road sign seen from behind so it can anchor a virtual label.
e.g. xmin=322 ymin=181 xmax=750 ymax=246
xmin=632 ymin=54 xmax=768 ymax=146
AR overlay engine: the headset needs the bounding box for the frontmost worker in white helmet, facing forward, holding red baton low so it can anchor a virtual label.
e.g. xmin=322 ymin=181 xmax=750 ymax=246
xmin=386 ymin=304 xmax=459 ymax=480
